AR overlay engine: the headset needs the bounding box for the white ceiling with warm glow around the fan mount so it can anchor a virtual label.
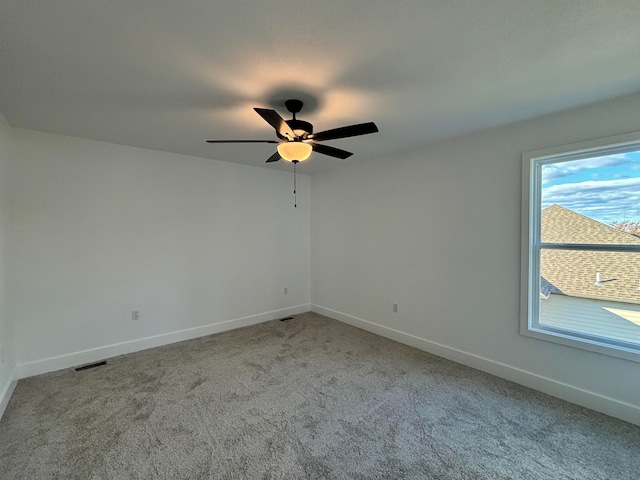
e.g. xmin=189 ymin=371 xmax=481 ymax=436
xmin=0 ymin=0 xmax=640 ymax=174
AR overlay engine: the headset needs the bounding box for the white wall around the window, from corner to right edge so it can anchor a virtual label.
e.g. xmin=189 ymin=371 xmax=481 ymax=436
xmin=311 ymin=90 xmax=640 ymax=423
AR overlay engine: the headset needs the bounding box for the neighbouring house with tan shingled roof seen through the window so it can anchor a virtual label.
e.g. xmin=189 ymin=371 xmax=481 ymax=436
xmin=540 ymin=205 xmax=640 ymax=344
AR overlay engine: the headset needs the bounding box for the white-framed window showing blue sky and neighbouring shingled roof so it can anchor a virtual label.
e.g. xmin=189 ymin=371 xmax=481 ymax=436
xmin=520 ymin=132 xmax=640 ymax=362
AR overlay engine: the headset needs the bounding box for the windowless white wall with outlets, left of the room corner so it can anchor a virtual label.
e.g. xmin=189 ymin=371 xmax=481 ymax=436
xmin=9 ymin=129 xmax=310 ymax=377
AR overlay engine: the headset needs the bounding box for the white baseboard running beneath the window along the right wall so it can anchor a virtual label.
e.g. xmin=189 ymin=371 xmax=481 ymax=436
xmin=311 ymin=304 xmax=640 ymax=425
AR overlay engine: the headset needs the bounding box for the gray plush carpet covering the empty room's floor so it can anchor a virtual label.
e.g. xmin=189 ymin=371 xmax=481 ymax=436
xmin=0 ymin=313 xmax=640 ymax=480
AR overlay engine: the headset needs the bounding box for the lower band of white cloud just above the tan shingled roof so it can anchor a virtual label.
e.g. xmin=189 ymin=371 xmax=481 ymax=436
xmin=542 ymin=178 xmax=640 ymax=223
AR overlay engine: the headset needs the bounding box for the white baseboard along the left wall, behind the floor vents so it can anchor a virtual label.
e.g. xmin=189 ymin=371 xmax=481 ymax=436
xmin=16 ymin=304 xmax=310 ymax=379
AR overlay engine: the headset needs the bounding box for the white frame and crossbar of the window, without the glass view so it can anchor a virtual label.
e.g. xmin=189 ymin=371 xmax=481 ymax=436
xmin=520 ymin=132 xmax=640 ymax=362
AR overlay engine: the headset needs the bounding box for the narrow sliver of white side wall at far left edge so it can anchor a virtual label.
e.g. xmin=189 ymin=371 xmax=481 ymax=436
xmin=0 ymin=114 xmax=16 ymax=416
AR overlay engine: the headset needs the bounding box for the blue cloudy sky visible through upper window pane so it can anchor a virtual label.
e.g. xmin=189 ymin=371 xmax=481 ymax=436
xmin=542 ymin=150 xmax=640 ymax=225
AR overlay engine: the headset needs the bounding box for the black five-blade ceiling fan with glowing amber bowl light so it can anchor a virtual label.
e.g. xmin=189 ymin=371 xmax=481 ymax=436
xmin=207 ymin=99 xmax=378 ymax=165
